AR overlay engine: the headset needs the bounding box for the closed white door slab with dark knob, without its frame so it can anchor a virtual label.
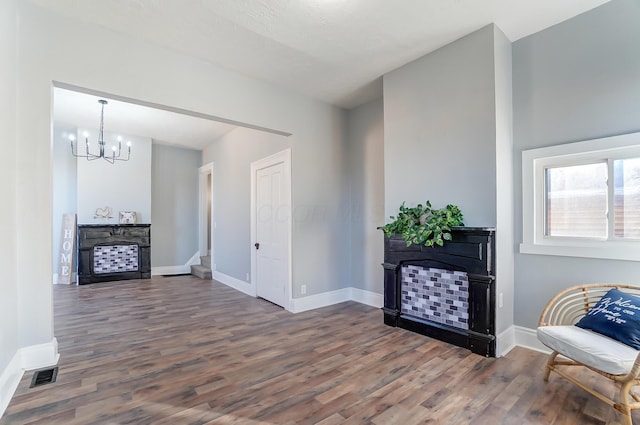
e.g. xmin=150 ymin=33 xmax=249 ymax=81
xmin=254 ymin=163 xmax=290 ymax=307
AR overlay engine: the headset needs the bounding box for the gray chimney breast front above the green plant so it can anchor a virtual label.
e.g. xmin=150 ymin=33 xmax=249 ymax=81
xmin=384 ymin=25 xmax=496 ymax=226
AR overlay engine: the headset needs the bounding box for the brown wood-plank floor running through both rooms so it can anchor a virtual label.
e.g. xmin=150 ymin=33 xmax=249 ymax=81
xmin=0 ymin=276 xmax=640 ymax=425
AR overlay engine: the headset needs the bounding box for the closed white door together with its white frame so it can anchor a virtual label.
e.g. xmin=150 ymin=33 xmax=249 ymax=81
xmin=251 ymin=149 xmax=291 ymax=310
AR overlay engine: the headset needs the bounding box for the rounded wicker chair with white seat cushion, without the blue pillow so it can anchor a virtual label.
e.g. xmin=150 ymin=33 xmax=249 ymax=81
xmin=538 ymin=284 xmax=640 ymax=425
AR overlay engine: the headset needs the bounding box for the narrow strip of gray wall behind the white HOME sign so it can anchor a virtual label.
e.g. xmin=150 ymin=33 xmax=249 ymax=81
xmin=51 ymin=126 xmax=78 ymax=274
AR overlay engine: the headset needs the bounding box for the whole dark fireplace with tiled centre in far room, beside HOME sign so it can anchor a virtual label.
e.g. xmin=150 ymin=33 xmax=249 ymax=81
xmin=78 ymin=224 xmax=151 ymax=285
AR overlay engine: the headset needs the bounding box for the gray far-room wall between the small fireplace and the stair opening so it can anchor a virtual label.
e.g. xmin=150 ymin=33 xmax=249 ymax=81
xmin=151 ymin=143 xmax=204 ymax=267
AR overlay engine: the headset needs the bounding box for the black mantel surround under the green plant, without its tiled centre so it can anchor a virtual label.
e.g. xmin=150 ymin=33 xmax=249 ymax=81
xmin=382 ymin=227 xmax=496 ymax=357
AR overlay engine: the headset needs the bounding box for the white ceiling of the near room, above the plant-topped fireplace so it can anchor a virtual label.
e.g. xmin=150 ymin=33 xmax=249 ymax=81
xmin=45 ymin=0 xmax=609 ymax=149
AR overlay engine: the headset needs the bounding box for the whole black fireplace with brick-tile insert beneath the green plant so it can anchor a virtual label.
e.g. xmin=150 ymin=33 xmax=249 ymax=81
xmin=383 ymin=227 xmax=496 ymax=357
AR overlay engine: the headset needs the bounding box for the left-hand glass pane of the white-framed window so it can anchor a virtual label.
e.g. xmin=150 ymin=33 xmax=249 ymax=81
xmin=545 ymin=162 xmax=607 ymax=238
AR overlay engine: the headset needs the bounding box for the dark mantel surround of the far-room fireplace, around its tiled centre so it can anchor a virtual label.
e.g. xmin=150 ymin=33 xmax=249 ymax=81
xmin=78 ymin=224 xmax=151 ymax=285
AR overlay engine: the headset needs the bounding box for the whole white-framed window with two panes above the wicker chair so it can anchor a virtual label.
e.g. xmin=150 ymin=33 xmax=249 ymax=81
xmin=520 ymin=133 xmax=640 ymax=261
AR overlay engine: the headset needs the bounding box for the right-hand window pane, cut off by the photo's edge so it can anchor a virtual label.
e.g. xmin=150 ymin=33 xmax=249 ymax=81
xmin=613 ymin=158 xmax=640 ymax=238
